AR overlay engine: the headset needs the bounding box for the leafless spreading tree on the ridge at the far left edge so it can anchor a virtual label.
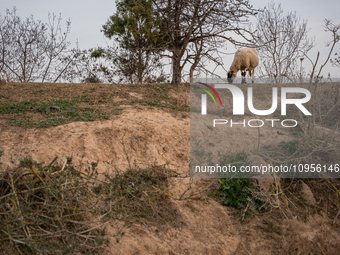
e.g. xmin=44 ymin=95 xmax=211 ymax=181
xmin=0 ymin=8 xmax=75 ymax=82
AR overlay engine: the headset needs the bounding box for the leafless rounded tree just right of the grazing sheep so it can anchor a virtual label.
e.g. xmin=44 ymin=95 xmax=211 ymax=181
xmin=254 ymin=3 xmax=314 ymax=82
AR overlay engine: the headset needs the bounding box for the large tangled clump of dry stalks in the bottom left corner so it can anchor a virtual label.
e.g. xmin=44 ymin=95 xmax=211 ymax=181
xmin=0 ymin=157 xmax=107 ymax=254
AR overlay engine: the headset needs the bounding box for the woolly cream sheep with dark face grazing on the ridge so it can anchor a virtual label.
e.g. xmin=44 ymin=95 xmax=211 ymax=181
xmin=228 ymin=48 xmax=259 ymax=83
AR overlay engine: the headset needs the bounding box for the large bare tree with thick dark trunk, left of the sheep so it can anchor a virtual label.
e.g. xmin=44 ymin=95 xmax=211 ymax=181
xmin=153 ymin=0 xmax=257 ymax=86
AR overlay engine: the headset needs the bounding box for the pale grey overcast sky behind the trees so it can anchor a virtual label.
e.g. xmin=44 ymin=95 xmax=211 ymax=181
xmin=0 ymin=0 xmax=340 ymax=78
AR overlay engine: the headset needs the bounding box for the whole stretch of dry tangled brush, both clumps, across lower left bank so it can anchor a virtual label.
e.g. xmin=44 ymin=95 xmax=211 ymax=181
xmin=0 ymin=151 xmax=183 ymax=254
